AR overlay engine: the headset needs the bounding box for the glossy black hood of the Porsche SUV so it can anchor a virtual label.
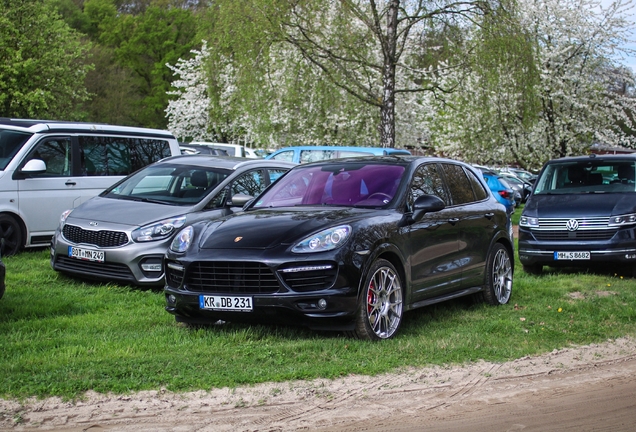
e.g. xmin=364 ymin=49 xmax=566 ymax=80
xmin=200 ymin=207 xmax=373 ymax=249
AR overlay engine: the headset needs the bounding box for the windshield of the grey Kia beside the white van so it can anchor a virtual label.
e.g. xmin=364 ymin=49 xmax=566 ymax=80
xmin=101 ymin=164 xmax=230 ymax=206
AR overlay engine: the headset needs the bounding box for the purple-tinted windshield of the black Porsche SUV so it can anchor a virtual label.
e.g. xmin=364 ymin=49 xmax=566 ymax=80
xmin=254 ymin=162 xmax=405 ymax=208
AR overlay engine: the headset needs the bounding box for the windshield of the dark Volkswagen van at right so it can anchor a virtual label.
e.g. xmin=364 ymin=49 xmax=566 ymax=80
xmin=534 ymin=159 xmax=636 ymax=195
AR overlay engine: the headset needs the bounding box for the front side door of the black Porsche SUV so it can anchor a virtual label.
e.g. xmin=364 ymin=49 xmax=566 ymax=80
xmin=404 ymin=163 xmax=461 ymax=302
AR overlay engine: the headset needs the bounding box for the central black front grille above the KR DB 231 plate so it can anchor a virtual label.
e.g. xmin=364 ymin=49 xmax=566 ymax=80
xmin=185 ymin=261 xmax=280 ymax=294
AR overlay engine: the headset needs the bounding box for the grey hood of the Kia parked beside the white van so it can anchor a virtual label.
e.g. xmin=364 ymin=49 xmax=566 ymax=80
xmin=68 ymin=197 xmax=192 ymax=226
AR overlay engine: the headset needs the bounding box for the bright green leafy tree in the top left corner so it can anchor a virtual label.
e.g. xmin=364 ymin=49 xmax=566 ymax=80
xmin=0 ymin=0 xmax=90 ymax=120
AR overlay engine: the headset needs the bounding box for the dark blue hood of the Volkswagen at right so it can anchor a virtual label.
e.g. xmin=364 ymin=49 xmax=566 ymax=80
xmin=523 ymin=193 xmax=636 ymax=218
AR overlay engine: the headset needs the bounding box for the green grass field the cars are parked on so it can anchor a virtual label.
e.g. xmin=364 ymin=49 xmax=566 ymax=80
xmin=0 ymin=245 xmax=636 ymax=398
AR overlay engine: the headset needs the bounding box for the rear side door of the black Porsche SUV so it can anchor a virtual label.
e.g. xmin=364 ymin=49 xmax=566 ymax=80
xmin=441 ymin=163 xmax=495 ymax=288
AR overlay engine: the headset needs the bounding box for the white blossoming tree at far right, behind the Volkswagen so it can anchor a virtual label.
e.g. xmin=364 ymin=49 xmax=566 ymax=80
xmin=426 ymin=0 xmax=636 ymax=168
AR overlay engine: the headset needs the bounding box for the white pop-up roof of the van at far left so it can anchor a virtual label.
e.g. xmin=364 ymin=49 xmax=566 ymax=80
xmin=0 ymin=117 xmax=174 ymax=138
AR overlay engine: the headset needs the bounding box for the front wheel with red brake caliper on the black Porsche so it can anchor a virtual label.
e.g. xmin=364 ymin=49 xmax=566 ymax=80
xmin=351 ymin=259 xmax=404 ymax=341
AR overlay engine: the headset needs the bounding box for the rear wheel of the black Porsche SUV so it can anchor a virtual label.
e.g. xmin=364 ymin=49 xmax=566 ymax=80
xmin=482 ymin=243 xmax=513 ymax=306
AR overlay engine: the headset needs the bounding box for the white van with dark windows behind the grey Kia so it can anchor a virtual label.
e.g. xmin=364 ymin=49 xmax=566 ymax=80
xmin=0 ymin=118 xmax=181 ymax=255
